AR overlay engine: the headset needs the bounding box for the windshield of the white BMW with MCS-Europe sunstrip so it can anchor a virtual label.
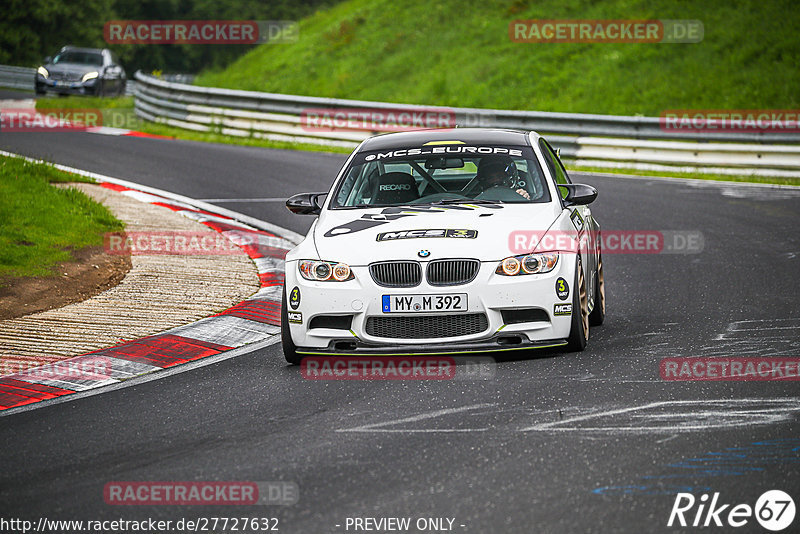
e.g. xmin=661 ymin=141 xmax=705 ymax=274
xmin=331 ymin=145 xmax=550 ymax=208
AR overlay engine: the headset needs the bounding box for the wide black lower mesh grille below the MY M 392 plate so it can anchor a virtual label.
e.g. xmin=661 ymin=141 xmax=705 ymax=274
xmin=367 ymin=313 xmax=489 ymax=339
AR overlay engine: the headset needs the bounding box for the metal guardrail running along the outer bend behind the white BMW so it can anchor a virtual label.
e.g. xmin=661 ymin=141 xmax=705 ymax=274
xmin=135 ymin=72 xmax=800 ymax=177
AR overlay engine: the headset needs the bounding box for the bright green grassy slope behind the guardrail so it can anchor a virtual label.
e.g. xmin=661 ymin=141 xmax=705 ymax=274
xmin=196 ymin=0 xmax=800 ymax=116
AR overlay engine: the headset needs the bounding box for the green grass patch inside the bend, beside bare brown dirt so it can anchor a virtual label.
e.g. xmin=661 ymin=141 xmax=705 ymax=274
xmin=0 ymin=157 xmax=124 ymax=285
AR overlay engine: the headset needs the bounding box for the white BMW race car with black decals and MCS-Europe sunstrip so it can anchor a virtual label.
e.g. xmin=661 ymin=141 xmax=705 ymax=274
xmin=281 ymin=128 xmax=605 ymax=364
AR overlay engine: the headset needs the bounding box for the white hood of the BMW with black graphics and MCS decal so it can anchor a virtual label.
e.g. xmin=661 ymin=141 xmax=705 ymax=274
xmin=313 ymin=203 xmax=561 ymax=266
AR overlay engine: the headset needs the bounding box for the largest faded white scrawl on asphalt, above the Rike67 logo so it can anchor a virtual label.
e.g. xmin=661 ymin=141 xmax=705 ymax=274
xmin=520 ymin=397 xmax=800 ymax=434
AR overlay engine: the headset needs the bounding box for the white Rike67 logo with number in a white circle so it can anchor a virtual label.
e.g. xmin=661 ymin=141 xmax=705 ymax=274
xmin=667 ymin=490 xmax=795 ymax=532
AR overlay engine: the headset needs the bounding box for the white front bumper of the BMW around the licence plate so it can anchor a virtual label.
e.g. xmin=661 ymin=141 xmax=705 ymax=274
xmin=286 ymin=254 xmax=575 ymax=354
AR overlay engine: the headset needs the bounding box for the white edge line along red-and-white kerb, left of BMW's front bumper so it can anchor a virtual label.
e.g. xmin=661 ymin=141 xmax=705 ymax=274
xmin=0 ymin=336 xmax=281 ymax=417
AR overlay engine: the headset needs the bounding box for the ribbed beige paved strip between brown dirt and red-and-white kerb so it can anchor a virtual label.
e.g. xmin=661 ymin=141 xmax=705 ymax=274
xmin=0 ymin=183 xmax=259 ymax=374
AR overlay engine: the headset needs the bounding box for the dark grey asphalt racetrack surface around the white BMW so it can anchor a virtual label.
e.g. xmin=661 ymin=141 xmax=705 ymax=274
xmin=0 ymin=133 xmax=800 ymax=533
